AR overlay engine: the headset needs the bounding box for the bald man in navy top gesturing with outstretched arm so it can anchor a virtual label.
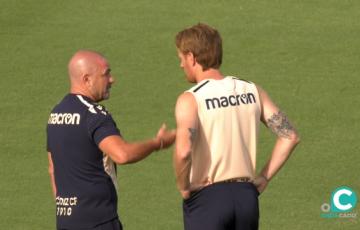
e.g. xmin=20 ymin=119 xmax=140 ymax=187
xmin=47 ymin=50 xmax=175 ymax=230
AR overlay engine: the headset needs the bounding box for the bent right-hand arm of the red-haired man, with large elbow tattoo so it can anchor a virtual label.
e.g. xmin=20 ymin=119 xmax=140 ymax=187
xmin=254 ymin=87 xmax=300 ymax=192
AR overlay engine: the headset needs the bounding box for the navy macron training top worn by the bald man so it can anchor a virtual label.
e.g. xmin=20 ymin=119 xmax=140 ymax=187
xmin=47 ymin=94 xmax=120 ymax=229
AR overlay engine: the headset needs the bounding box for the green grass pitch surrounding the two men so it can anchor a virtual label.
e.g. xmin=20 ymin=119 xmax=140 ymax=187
xmin=0 ymin=0 xmax=360 ymax=230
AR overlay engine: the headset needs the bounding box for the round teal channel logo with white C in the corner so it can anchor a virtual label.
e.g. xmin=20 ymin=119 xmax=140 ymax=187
xmin=320 ymin=186 xmax=357 ymax=218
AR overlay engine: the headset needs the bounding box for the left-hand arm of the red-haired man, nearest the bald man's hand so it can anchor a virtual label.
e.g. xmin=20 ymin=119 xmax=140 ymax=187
xmin=174 ymin=93 xmax=198 ymax=199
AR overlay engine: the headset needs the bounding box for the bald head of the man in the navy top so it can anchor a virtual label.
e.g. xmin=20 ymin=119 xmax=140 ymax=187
xmin=68 ymin=50 xmax=113 ymax=101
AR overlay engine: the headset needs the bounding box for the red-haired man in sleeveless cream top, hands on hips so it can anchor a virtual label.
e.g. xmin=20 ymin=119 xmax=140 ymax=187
xmin=174 ymin=23 xmax=299 ymax=230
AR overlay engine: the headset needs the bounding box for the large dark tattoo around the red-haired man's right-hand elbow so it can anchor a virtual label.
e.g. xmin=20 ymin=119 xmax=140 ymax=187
xmin=266 ymin=111 xmax=296 ymax=139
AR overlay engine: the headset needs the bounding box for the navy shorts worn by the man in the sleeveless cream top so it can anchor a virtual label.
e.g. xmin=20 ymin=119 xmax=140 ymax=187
xmin=183 ymin=182 xmax=259 ymax=230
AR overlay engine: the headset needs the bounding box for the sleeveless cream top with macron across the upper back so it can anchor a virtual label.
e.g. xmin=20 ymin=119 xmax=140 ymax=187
xmin=188 ymin=77 xmax=261 ymax=188
